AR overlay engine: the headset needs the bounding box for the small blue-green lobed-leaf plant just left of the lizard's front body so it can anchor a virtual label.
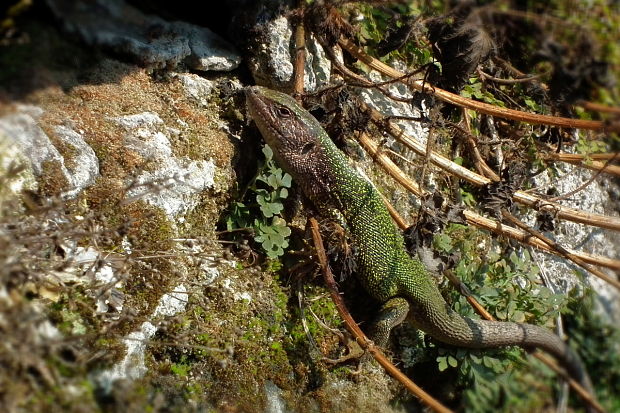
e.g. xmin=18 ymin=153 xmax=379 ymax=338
xmin=226 ymin=145 xmax=292 ymax=258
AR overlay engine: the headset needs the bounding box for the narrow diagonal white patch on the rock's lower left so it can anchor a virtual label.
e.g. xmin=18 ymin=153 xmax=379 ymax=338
xmin=96 ymin=284 xmax=189 ymax=393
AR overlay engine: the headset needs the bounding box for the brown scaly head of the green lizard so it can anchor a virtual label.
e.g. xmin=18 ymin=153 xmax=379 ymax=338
xmin=245 ymin=86 xmax=325 ymax=182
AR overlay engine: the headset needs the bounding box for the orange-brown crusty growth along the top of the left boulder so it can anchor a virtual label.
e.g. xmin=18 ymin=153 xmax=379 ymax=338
xmin=32 ymin=60 xmax=234 ymax=176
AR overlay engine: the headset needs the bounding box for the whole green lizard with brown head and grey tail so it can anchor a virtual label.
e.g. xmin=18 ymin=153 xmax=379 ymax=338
xmin=246 ymin=86 xmax=593 ymax=400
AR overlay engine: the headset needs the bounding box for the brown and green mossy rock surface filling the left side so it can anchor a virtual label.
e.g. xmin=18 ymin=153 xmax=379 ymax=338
xmin=0 ymin=10 xmax=398 ymax=412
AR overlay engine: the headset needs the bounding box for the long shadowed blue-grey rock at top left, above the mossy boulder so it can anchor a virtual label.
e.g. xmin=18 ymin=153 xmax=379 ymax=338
xmin=47 ymin=0 xmax=241 ymax=71
